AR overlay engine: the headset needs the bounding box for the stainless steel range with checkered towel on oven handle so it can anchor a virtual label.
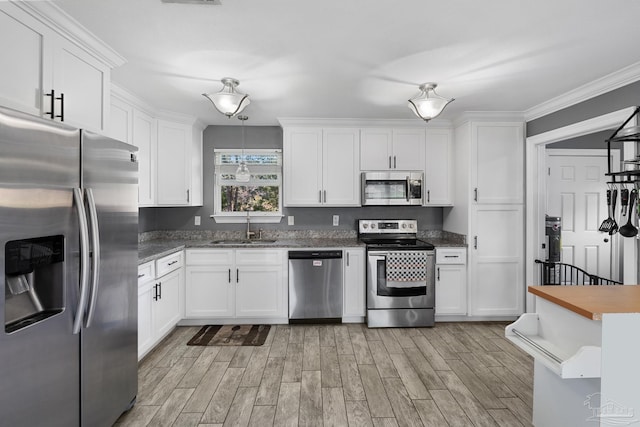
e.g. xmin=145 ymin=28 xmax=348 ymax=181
xmin=358 ymin=219 xmax=435 ymax=328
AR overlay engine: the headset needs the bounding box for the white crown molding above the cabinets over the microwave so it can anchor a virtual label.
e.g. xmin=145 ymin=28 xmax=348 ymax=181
xmin=278 ymin=117 xmax=451 ymax=129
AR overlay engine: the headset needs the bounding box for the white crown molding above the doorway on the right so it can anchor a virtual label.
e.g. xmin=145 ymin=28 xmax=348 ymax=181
xmin=524 ymin=62 xmax=640 ymax=121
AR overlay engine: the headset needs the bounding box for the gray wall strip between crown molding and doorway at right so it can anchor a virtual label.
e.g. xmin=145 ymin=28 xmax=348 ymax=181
xmin=527 ymin=81 xmax=640 ymax=136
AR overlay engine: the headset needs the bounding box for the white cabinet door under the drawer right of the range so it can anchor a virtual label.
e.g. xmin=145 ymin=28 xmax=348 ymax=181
xmin=436 ymin=264 xmax=467 ymax=315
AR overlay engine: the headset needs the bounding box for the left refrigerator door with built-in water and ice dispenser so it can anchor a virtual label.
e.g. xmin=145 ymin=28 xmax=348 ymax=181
xmin=0 ymin=109 xmax=80 ymax=426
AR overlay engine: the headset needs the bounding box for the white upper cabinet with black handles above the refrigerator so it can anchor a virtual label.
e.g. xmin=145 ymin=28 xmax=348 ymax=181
xmin=0 ymin=2 xmax=125 ymax=134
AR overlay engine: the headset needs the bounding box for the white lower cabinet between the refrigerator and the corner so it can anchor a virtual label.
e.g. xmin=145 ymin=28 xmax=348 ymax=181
xmin=138 ymin=251 xmax=183 ymax=359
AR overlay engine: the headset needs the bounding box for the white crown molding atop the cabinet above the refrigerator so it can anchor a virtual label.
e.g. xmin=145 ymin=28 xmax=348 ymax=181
xmin=13 ymin=1 xmax=127 ymax=68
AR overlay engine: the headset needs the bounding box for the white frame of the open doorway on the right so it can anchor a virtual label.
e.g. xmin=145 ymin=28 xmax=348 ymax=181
xmin=525 ymin=107 xmax=637 ymax=312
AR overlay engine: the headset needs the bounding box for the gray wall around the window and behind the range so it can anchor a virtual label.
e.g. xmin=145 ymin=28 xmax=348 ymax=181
xmin=139 ymin=126 xmax=442 ymax=232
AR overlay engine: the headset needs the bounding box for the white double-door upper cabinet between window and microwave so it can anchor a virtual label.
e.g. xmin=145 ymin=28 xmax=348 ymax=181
xmin=283 ymin=127 xmax=360 ymax=206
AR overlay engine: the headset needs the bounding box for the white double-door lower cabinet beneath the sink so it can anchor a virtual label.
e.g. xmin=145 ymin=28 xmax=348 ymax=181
xmin=185 ymin=249 xmax=288 ymax=323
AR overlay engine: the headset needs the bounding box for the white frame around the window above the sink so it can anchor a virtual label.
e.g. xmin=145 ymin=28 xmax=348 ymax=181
xmin=211 ymin=148 xmax=284 ymax=224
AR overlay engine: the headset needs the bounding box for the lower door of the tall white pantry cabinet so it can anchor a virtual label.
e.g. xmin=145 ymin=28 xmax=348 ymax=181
xmin=469 ymin=205 xmax=525 ymax=316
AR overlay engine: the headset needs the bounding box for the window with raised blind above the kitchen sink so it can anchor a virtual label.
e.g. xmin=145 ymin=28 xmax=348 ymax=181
xmin=213 ymin=149 xmax=282 ymax=222
